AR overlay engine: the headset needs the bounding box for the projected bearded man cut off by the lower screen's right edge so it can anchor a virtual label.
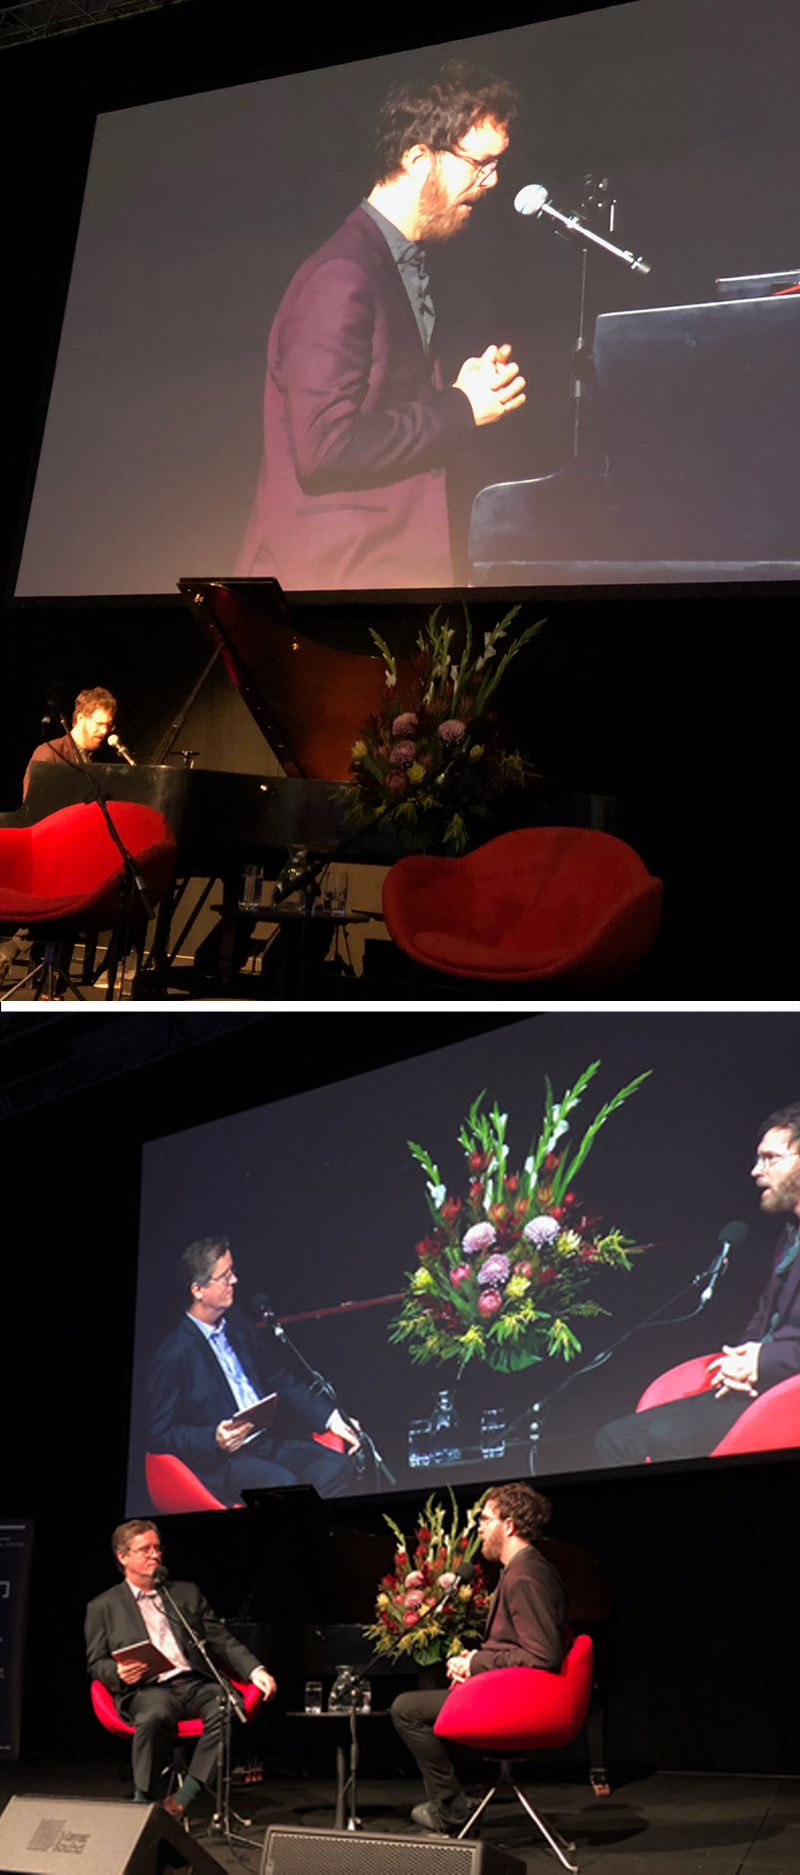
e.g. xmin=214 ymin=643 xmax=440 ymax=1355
xmin=596 ymin=1101 xmax=800 ymax=1464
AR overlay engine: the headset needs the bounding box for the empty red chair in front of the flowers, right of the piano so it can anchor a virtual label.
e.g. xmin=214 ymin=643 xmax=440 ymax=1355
xmin=382 ymin=827 xmax=663 ymax=990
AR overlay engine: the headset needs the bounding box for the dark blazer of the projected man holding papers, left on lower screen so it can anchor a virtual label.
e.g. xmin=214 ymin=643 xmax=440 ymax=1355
xmin=148 ymin=1309 xmax=330 ymax=1496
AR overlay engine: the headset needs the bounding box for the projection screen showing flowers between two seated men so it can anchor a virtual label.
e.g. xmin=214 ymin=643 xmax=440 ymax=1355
xmin=127 ymin=1013 xmax=800 ymax=1515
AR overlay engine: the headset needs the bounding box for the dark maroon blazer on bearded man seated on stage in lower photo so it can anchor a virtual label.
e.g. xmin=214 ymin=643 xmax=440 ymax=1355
xmin=470 ymin=1545 xmax=570 ymax=1674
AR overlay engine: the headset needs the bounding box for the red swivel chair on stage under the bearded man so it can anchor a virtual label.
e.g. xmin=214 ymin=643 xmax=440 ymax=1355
xmin=433 ymin=1635 xmax=594 ymax=1871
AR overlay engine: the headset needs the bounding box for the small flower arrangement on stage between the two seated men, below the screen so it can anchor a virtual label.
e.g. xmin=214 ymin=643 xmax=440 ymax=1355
xmin=363 ymin=1487 xmax=489 ymax=1667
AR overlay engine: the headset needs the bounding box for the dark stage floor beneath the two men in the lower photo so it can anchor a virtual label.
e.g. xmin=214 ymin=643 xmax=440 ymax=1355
xmin=0 ymin=1759 xmax=800 ymax=1875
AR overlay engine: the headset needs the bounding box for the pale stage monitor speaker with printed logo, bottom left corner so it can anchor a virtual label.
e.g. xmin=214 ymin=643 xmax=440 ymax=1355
xmin=0 ymin=1796 xmax=221 ymax=1875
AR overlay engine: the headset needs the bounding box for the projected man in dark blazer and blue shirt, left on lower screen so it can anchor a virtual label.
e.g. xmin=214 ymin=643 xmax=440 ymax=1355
xmin=148 ymin=1238 xmax=360 ymax=1504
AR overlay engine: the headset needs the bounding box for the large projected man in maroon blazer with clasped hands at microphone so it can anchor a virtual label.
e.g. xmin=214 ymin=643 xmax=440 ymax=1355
xmin=236 ymin=62 xmax=525 ymax=591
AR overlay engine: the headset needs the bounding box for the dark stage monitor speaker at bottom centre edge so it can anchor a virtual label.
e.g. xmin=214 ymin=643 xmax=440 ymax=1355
xmin=260 ymin=1828 xmax=525 ymax=1875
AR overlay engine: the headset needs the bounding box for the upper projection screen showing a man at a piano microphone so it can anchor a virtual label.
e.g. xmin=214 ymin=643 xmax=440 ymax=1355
xmin=17 ymin=0 xmax=800 ymax=596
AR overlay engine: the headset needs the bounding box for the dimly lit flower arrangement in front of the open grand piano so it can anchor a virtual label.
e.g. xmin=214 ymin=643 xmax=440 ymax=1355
xmin=339 ymin=606 xmax=545 ymax=853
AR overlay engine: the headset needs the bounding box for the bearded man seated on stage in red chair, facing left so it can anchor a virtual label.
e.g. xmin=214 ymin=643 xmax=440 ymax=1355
xmin=392 ymin=1483 xmax=568 ymax=1836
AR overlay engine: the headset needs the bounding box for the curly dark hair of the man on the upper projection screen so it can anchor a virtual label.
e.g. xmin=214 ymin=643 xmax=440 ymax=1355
xmin=373 ymin=58 xmax=517 ymax=182
